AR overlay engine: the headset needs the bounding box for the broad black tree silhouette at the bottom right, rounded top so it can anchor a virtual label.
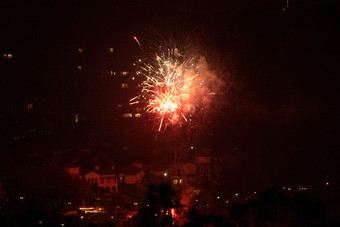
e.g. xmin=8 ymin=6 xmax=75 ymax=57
xmin=230 ymin=189 xmax=326 ymax=227
